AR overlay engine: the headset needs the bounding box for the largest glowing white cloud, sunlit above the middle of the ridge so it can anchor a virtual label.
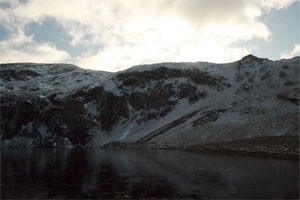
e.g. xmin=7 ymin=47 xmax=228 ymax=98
xmin=0 ymin=0 xmax=294 ymax=71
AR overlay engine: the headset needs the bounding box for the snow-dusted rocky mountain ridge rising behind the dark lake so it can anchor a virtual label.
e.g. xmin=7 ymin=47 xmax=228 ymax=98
xmin=0 ymin=55 xmax=300 ymax=155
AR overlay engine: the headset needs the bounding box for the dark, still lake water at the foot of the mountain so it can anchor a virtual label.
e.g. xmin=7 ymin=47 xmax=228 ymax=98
xmin=0 ymin=149 xmax=299 ymax=199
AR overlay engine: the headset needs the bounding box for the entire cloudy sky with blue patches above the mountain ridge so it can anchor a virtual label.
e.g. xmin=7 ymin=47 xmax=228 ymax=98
xmin=0 ymin=0 xmax=300 ymax=72
